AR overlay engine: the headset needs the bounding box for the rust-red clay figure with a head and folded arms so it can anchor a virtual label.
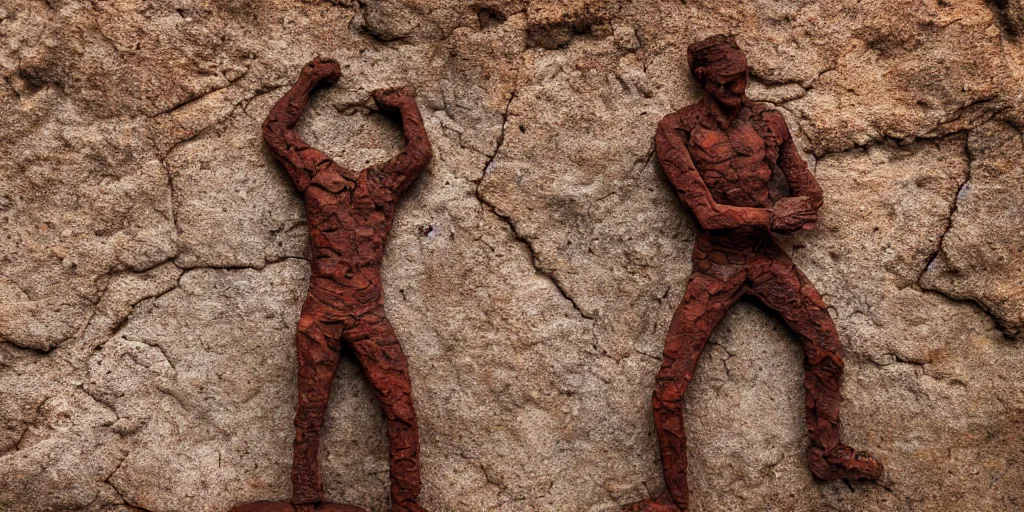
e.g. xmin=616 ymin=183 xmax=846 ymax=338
xmin=625 ymin=35 xmax=882 ymax=512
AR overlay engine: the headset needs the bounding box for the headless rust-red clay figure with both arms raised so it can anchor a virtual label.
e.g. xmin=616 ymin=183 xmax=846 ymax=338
xmin=232 ymin=58 xmax=431 ymax=512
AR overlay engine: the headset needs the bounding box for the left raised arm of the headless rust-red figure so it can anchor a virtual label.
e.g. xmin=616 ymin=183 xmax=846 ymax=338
xmin=263 ymin=57 xmax=341 ymax=190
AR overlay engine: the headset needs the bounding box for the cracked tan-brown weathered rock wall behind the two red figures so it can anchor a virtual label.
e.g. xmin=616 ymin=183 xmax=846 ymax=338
xmin=0 ymin=0 xmax=1024 ymax=511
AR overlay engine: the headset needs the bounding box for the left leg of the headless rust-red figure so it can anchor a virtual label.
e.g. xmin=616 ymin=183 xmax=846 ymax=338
xmin=292 ymin=302 xmax=340 ymax=505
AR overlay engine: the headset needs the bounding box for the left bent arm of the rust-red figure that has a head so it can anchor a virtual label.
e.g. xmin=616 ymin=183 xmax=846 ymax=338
xmin=654 ymin=115 xmax=772 ymax=229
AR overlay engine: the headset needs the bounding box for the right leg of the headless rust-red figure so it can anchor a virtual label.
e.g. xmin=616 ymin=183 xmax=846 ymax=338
xmin=345 ymin=307 xmax=423 ymax=512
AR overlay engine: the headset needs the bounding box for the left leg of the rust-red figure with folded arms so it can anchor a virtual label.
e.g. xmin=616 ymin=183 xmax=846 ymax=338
xmin=625 ymin=272 xmax=743 ymax=512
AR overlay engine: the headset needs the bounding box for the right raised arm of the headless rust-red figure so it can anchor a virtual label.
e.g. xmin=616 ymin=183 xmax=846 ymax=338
xmin=371 ymin=87 xmax=433 ymax=194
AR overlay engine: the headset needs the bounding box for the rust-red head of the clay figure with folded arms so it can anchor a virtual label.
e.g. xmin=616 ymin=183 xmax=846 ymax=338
xmin=686 ymin=34 xmax=748 ymax=109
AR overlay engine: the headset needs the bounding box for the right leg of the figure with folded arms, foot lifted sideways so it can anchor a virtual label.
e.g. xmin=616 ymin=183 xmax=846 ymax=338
xmin=750 ymin=258 xmax=882 ymax=480
